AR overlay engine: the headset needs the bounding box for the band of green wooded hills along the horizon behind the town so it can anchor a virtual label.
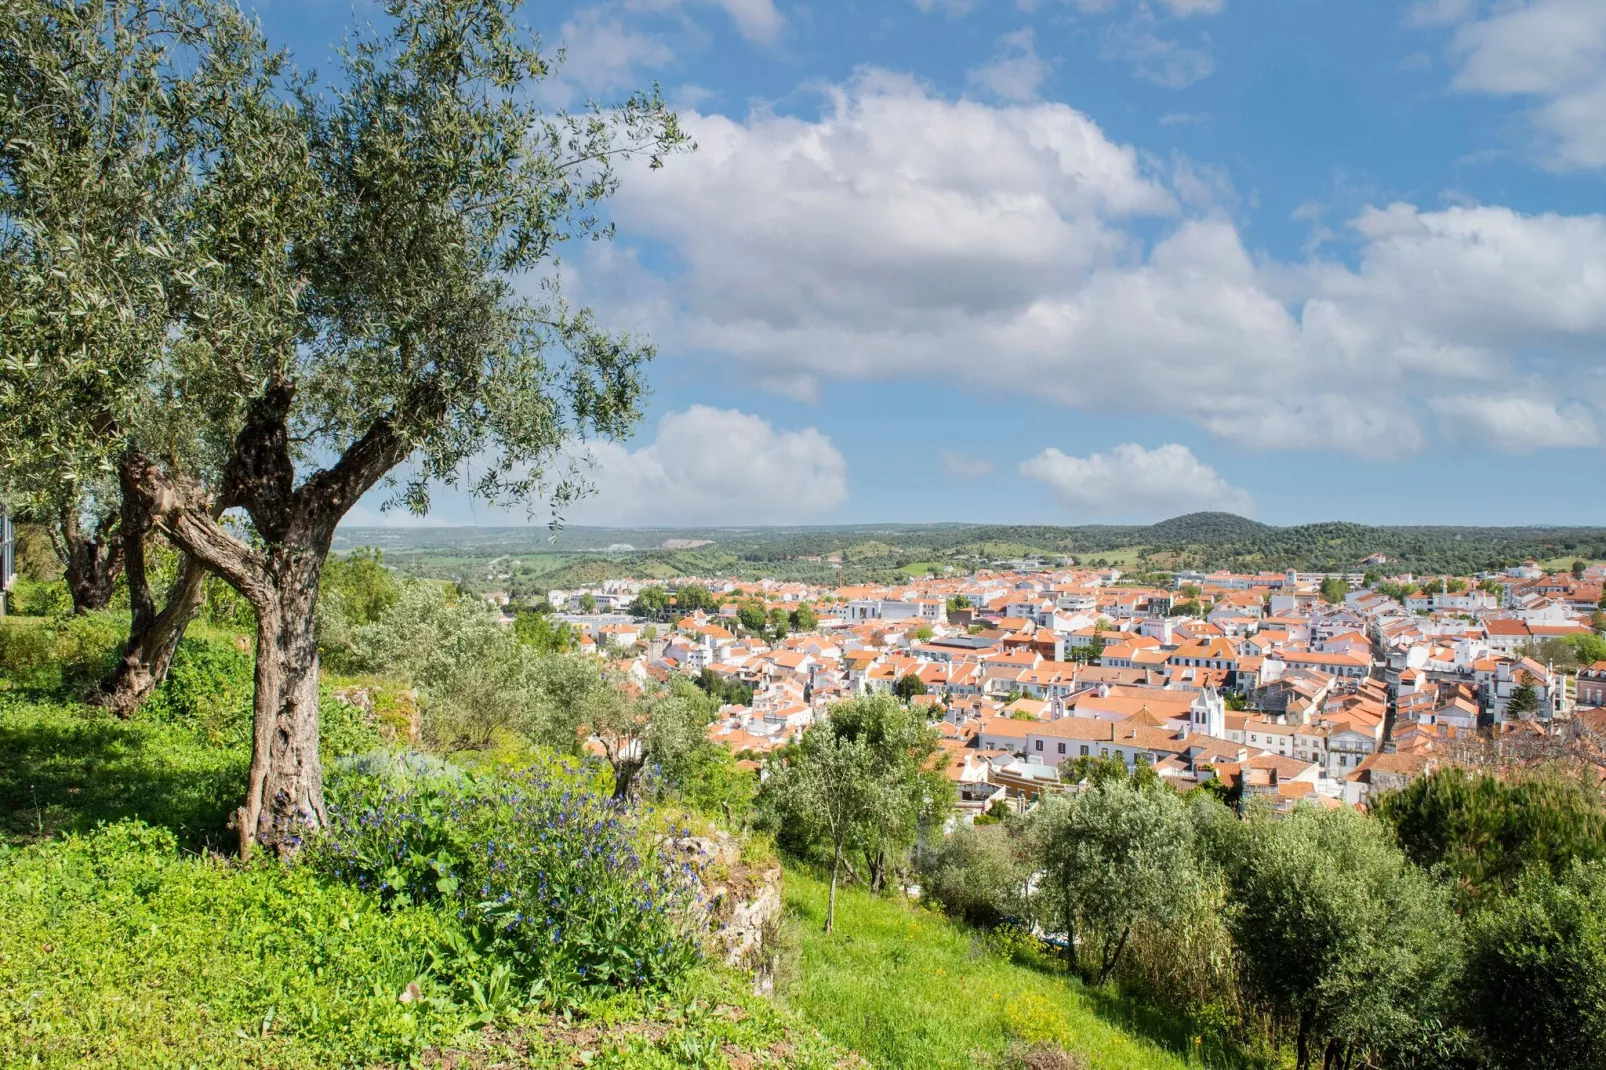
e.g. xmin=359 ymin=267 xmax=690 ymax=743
xmin=336 ymin=513 xmax=1606 ymax=590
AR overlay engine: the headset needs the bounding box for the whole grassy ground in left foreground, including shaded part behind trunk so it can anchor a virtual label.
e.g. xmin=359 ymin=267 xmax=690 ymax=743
xmin=0 ymin=649 xmax=843 ymax=1070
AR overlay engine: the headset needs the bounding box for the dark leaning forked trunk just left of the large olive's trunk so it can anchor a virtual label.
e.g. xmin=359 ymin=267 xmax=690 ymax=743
xmin=90 ymin=469 xmax=206 ymax=718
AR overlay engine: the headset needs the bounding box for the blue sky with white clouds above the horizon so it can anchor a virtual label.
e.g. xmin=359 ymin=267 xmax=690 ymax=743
xmin=259 ymin=0 xmax=1606 ymax=524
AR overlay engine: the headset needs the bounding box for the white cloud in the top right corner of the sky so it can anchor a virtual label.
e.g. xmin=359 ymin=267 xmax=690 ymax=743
xmin=1415 ymin=0 xmax=1606 ymax=170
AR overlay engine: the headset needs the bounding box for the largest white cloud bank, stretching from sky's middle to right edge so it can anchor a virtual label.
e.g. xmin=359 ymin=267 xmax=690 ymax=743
xmin=597 ymin=71 xmax=1606 ymax=458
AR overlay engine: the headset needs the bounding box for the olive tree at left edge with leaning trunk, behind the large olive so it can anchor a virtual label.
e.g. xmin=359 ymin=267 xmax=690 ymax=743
xmin=0 ymin=0 xmax=223 ymax=700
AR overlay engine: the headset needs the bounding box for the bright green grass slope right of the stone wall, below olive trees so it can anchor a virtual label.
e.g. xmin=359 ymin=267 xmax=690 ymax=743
xmin=782 ymin=871 xmax=1238 ymax=1070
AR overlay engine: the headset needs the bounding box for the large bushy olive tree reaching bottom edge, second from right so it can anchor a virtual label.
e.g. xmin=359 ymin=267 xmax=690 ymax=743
xmin=1217 ymin=807 xmax=1465 ymax=1070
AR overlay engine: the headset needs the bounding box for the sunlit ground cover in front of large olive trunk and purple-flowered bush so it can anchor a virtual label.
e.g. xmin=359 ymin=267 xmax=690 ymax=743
xmin=0 ymin=823 xmax=842 ymax=1070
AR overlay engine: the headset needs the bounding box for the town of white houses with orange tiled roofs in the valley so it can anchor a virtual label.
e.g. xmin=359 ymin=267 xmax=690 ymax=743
xmin=485 ymin=554 xmax=1606 ymax=818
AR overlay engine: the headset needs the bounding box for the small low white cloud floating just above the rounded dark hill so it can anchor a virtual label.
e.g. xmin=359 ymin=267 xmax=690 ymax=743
xmin=1020 ymin=442 xmax=1254 ymax=521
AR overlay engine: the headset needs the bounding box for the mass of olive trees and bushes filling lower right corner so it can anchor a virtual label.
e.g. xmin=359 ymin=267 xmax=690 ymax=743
xmin=917 ymin=763 xmax=1606 ymax=1070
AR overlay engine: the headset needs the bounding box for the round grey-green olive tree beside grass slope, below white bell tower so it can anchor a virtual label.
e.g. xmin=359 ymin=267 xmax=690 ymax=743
xmin=1033 ymin=767 xmax=1198 ymax=985
